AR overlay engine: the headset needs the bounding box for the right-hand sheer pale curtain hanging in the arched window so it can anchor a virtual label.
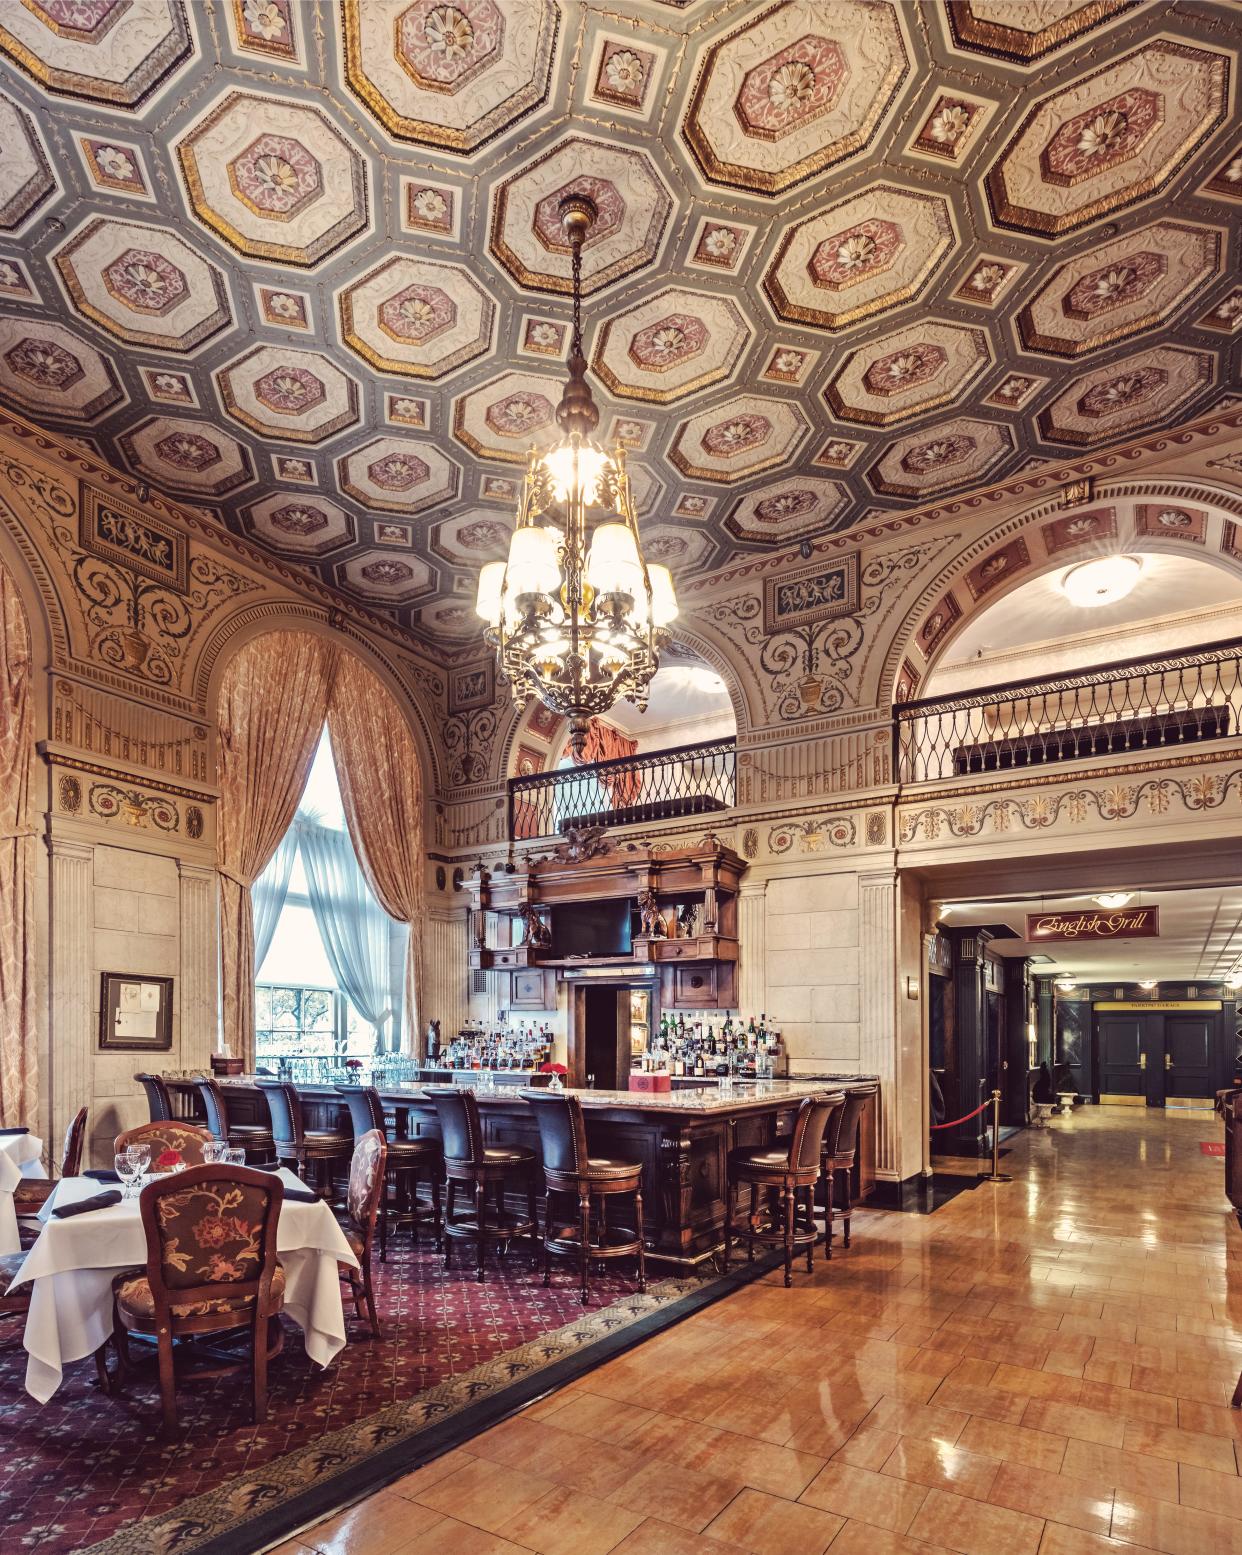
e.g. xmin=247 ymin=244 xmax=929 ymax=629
xmin=295 ymin=821 xmax=409 ymax=1053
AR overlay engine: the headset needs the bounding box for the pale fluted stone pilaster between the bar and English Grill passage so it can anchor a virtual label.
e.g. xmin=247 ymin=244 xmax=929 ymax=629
xmin=858 ymin=869 xmax=902 ymax=1177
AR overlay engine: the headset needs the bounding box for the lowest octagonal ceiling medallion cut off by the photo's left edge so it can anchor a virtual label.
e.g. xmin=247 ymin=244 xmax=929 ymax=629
xmin=0 ymin=317 xmax=124 ymax=423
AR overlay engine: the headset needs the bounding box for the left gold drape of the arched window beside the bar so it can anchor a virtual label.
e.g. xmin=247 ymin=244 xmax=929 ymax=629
xmin=216 ymin=631 xmax=340 ymax=1071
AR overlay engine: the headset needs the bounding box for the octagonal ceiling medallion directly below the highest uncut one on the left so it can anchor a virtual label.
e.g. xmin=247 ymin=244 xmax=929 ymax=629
xmin=216 ymin=345 xmax=358 ymax=443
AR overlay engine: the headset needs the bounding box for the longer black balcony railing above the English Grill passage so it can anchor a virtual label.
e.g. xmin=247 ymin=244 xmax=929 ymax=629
xmin=894 ymin=639 xmax=1242 ymax=782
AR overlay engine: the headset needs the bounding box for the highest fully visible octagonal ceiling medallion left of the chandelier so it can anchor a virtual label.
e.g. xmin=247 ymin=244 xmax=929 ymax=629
xmin=177 ymin=92 xmax=368 ymax=267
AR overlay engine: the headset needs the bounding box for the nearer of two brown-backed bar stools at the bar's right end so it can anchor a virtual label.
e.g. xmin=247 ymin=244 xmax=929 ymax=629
xmin=724 ymin=1090 xmax=846 ymax=1286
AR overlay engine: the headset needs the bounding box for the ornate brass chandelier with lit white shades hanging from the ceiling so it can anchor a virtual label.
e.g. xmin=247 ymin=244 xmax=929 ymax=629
xmin=476 ymin=194 xmax=678 ymax=757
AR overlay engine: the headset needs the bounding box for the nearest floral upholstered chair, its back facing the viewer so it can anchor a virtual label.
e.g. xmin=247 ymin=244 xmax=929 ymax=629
xmin=112 ymin=1166 xmax=284 ymax=1432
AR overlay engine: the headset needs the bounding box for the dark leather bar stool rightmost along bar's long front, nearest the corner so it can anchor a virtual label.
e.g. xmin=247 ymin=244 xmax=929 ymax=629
xmin=522 ymin=1089 xmax=647 ymax=1306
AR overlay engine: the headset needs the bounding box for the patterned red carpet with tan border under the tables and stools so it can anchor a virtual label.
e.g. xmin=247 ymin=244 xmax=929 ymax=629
xmin=0 ymin=1236 xmax=693 ymax=1555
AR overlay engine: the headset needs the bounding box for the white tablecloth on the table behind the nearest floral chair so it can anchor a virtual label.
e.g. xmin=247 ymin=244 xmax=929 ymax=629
xmin=14 ymin=1169 xmax=358 ymax=1404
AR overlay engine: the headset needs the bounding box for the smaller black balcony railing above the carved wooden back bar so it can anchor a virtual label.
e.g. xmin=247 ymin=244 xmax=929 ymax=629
xmin=508 ymin=740 xmax=737 ymax=838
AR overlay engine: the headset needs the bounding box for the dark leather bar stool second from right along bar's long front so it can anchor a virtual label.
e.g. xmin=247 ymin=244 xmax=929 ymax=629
xmin=423 ymin=1085 xmax=539 ymax=1281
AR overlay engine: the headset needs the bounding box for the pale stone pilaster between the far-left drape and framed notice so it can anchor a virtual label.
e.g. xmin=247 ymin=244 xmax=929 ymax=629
xmin=47 ymin=837 xmax=95 ymax=1166
